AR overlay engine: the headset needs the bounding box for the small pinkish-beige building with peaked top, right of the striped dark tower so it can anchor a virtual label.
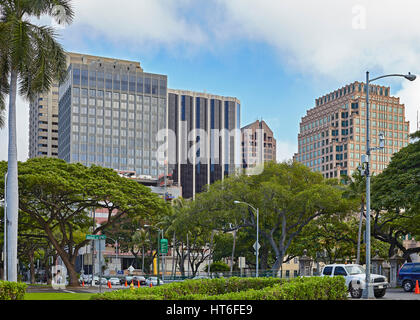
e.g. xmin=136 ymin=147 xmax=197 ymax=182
xmin=241 ymin=120 xmax=276 ymax=169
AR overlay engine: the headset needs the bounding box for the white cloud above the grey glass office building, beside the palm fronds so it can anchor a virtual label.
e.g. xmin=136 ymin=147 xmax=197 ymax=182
xmin=73 ymin=0 xmax=206 ymax=47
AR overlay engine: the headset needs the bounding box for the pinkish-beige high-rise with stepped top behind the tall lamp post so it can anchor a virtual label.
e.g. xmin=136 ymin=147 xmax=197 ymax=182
xmin=293 ymin=82 xmax=409 ymax=178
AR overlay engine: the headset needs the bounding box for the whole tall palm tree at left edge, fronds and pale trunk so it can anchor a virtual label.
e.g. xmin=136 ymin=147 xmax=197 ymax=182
xmin=0 ymin=0 xmax=73 ymax=281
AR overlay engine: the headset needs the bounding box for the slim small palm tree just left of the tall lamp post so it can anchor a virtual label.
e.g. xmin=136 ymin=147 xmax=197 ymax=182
xmin=343 ymin=170 xmax=366 ymax=264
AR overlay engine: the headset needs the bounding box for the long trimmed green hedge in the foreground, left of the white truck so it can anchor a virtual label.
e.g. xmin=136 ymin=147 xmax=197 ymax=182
xmin=92 ymin=277 xmax=347 ymax=300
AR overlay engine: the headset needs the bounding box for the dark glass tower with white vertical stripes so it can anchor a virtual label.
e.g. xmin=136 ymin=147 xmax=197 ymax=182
xmin=168 ymin=89 xmax=242 ymax=198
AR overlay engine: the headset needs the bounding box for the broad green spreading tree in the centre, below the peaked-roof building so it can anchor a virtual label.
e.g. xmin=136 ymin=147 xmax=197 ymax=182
xmin=195 ymin=163 xmax=354 ymax=274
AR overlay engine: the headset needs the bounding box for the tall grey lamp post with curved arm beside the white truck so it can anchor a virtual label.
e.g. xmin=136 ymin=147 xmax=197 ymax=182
xmin=361 ymin=71 xmax=416 ymax=299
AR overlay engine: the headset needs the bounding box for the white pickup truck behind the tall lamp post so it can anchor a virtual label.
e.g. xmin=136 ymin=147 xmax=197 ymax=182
xmin=321 ymin=264 xmax=389 ymax=299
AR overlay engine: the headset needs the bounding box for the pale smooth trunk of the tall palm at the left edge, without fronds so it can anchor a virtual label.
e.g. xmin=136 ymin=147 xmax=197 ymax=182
xmin=6 ymin=69 xmax=19 ymax=282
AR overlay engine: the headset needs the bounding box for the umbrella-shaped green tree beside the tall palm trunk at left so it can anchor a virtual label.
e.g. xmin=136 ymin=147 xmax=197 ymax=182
xmin=0 ymin=158 xmax=167 ymax=286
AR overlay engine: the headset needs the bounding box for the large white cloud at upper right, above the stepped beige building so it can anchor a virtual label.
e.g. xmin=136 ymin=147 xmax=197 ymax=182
xmin=218 ymin=0 xmax=420 ymax=83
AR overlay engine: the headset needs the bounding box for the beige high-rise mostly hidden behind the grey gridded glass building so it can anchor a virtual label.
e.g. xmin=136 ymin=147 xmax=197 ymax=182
xmin=29 ymin=52 xmax=143 ymax=158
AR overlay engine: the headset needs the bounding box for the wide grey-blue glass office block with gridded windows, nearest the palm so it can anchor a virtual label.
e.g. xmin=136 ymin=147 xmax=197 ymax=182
xmin=58 ymin=55 xmax=167 ymax=178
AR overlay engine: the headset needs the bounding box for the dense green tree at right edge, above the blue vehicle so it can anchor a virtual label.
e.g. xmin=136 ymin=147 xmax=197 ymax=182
xmin=372 ymin=131 xmax=420 ymax=261
